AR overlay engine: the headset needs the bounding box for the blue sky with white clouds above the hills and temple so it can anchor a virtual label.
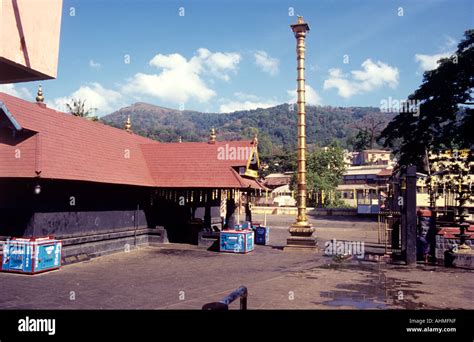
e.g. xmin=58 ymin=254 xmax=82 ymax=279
xmin=0 ymin=0 xmax=474 ymax=115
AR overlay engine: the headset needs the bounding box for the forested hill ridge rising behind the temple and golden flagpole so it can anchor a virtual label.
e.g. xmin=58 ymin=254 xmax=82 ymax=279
xmin=101 ymin=102 xmax=393 ymax=152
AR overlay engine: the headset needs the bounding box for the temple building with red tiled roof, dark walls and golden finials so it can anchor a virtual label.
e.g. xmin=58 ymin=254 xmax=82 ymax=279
xmin=0 ymin=93 xmax=264 ymax=260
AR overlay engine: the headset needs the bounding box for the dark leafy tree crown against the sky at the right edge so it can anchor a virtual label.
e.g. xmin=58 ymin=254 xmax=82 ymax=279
xmin=381 ymin=29 xmax=474 ymax=171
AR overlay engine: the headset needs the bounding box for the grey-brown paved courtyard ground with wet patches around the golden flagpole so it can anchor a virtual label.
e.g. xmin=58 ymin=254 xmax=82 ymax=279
xmin=0 ymin=216 xmax=474 ymax=309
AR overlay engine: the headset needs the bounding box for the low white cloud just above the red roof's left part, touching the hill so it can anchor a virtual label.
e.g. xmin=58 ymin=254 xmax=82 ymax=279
xmin=46 ymin=82 xmax=124 ymax=116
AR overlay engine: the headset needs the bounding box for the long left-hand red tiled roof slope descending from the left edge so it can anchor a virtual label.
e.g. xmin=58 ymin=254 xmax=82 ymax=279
xmin=0 ymin=93 xmax=159 ymax=186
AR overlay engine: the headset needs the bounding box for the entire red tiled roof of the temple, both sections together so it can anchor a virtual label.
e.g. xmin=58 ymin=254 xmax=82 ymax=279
xmin=0 ymin=93 xmax=260 ymax=188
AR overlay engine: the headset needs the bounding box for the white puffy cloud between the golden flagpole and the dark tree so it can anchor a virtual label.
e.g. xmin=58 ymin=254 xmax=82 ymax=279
xmin=324 ymin=58 xmax=399 ymax=98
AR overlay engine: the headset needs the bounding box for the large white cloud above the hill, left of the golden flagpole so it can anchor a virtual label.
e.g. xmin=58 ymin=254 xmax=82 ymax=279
xmin=122 ymin=48 xmax=241 ymax=104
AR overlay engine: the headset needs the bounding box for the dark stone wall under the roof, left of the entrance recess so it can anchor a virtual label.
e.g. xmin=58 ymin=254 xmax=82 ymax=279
xmin=0 ymin=179 xmax=156 ymax=238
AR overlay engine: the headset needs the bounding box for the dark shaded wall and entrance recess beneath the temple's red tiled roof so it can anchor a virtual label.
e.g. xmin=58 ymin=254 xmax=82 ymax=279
xmin=0 ymin=178 xmax=226 ymax=244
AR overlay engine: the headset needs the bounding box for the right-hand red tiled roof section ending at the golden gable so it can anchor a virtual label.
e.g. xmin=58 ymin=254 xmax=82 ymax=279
xmin=142 ymin=140 xmax=262 ymax=189
